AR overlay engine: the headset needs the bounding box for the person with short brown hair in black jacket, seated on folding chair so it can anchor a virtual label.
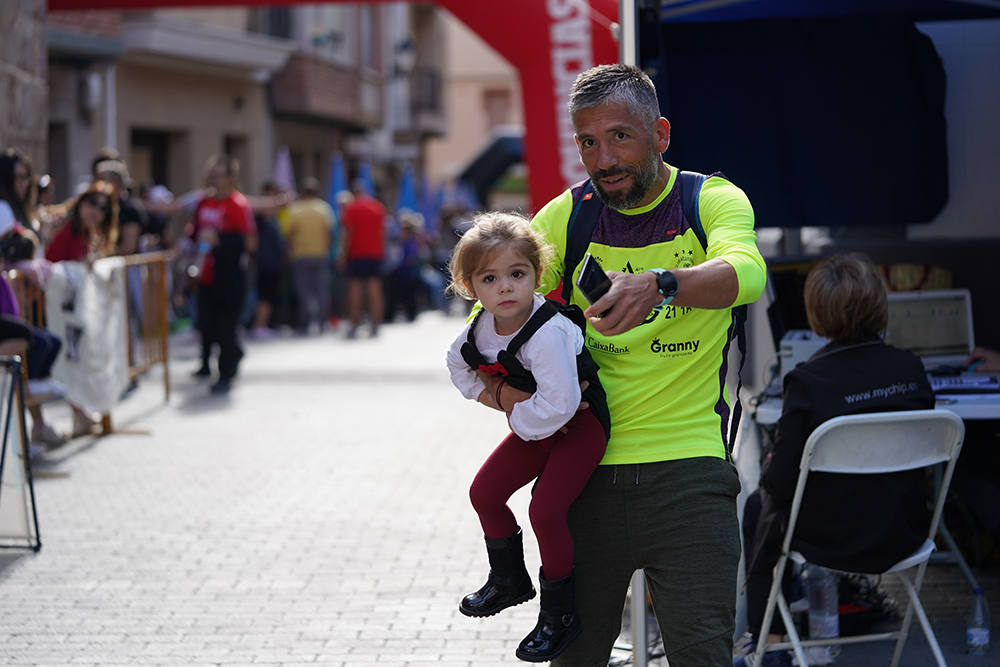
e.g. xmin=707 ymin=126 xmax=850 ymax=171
xmin=735 ymin=254 xmax=934 ymax=666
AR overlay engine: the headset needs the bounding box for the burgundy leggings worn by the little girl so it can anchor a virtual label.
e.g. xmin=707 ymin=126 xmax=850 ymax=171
xmin=469 ymin=410 xmax=607 ymax=581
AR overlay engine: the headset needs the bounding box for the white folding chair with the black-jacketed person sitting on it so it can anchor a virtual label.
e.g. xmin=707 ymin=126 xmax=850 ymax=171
xmin=756 ymin=410 xmax=965 ymax=667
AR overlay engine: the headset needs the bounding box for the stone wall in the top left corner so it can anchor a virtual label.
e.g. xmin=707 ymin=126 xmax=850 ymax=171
xmin=0 ymin=0 xmax=48 ymax=169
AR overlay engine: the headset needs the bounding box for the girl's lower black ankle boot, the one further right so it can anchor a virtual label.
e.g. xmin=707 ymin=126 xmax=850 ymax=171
xmin=515 ymin=569 xmax=582 ymax=662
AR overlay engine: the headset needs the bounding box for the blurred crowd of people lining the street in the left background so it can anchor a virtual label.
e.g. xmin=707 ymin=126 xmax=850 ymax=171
xmin=0 ymin=148 xmax=461 ymax=448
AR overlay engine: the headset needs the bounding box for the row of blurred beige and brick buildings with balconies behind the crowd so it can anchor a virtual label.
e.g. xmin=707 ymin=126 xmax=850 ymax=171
xmin=47 ymin=2 xmax=443 ymax=207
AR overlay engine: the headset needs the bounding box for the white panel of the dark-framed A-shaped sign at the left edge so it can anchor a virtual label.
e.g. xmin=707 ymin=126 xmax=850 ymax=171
xmin=0 ymin=366 xmax=39 ymax=549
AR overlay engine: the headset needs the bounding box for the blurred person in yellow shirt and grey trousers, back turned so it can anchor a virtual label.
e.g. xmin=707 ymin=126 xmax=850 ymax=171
xmin=288 ymin=178 xmax=333 ymax=333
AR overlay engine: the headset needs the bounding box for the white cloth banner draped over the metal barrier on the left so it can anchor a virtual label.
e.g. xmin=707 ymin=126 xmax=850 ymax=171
xmin=45 ymin=257 xmax=129 ymax=414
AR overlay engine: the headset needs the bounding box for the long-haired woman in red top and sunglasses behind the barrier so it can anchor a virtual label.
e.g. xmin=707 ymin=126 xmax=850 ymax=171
xmin=45 ymin=181 xmax=118 ymax=262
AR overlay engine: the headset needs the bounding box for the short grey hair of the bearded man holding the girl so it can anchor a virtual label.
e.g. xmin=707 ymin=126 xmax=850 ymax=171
xmin=569 ymin=63 xmax=660 ymax=127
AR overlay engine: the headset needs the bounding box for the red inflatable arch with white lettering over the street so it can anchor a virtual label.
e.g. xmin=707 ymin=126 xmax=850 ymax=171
xmin=49 ymin=0 xmax=618 ymax=210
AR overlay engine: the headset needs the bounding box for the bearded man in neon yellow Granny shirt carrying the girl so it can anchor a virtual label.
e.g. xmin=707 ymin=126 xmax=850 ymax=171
xmin=476 ymin=64 xmax=765 ymax=667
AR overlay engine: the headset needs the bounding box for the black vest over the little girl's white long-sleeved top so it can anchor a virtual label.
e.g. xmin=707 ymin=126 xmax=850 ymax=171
xmin=462 ymin=299 xmax=611 ymax=437
